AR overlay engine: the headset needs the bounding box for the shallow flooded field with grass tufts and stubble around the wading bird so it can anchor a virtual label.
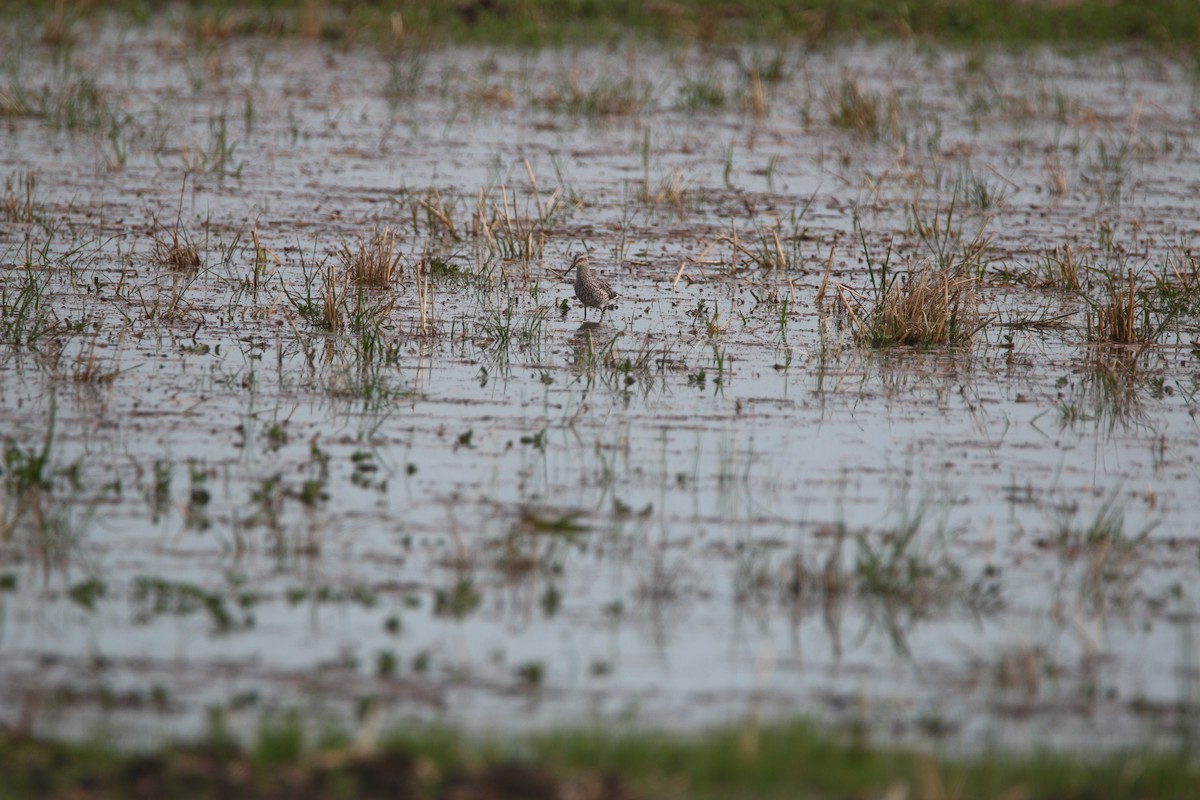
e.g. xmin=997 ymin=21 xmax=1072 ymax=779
xmin=0 ymin=21 xmax=1200 ymax=747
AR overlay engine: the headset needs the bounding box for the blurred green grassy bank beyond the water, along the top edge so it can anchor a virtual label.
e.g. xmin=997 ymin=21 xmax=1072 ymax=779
xmin=0 ymin=0 xmax=1200 ymax=53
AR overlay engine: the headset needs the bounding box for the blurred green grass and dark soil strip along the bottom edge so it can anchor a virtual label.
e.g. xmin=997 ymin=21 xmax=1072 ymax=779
xmin=0 ymin=721 xmax=1200 ymax=800
